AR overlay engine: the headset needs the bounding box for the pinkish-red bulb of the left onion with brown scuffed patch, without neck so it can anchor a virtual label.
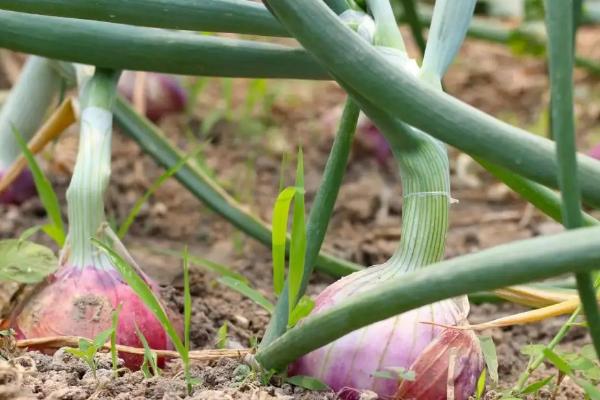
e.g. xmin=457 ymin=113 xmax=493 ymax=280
xmin=11 ymin=266 xmax=181 ymax=369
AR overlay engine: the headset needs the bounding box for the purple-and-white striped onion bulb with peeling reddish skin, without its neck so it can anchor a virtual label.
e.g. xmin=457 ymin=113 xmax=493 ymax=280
xmin=289 ymin=266 xmax=483 ymax=400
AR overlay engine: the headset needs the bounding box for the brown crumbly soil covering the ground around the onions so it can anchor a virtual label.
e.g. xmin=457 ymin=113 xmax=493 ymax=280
xmin=0 ymin=29 xmax=600 ymax=400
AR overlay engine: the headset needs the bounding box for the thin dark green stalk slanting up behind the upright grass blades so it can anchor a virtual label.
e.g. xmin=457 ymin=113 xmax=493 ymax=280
xmin=260 ymin=98 xmax=360 ymax=348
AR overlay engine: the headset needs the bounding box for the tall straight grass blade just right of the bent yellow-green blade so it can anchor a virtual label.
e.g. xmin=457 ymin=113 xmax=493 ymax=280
xmin=288 ymin=149 xmax=306 ymax=324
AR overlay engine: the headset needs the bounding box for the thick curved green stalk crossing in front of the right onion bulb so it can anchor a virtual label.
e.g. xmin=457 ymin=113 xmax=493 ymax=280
xmin=256 ymin=227 xmax=600 ymax=370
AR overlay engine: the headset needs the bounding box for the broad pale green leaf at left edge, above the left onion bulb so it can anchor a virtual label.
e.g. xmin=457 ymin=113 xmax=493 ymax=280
xmin=0 ymin=239 xmax=58 ymax=284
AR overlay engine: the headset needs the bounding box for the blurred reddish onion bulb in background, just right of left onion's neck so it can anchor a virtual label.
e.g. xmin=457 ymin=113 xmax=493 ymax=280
xmin=119 ymin=71 xmax=187 ymax=122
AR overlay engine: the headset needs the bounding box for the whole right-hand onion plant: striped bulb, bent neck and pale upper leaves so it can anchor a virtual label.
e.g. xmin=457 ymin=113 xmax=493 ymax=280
xmin=289 ymin=0 xmax=483 ymax=400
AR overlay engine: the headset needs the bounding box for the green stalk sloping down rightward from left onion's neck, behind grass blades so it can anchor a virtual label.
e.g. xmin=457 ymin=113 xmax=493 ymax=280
xmin=114 ymin=98 xmax=361 ymax=276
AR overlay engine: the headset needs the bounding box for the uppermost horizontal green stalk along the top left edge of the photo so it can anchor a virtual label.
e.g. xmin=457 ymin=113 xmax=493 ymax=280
xmin=0 ymin=0 xmax=288 ymax=36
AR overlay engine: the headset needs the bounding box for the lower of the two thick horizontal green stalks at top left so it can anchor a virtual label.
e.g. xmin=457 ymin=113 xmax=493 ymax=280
xmin=0 ymin=11 xmax=328 ymax=79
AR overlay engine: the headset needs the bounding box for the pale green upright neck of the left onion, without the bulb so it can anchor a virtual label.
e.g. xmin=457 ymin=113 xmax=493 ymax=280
xmin=67 ymin=70 xmax=119 ymax=269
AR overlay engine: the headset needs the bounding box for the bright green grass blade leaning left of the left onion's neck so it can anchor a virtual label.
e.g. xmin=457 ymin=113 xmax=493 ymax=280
xmin=13 ymin=127 xmax=66 ymax=247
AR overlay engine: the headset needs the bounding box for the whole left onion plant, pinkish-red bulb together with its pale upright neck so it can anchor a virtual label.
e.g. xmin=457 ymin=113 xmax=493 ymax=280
xmin=12 ymin=67 xmax=176 ymax=367
